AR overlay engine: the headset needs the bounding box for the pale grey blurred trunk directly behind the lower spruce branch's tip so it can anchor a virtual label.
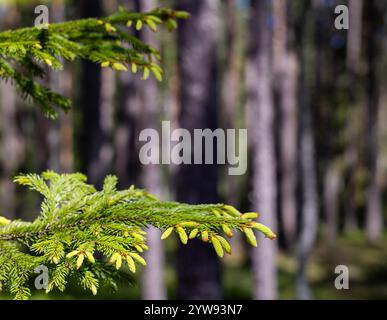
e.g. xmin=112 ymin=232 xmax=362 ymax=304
xmin=246 ymin=0 xmax=277 ymax=299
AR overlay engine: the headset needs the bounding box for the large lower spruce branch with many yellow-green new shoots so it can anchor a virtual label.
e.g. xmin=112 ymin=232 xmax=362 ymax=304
xmin=0 ymin=171 xmax=275 ymax=299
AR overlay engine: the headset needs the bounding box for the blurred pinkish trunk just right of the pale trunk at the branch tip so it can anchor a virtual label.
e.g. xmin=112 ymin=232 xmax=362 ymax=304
xmin=273 ymin=0 xmax=298 ymax=247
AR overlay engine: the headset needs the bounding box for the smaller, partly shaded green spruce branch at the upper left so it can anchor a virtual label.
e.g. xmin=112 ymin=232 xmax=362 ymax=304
xmin=0 ymin=8 xmax=189 ymax=118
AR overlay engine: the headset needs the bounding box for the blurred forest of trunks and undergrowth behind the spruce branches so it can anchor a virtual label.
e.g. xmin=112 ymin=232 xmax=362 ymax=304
xmin=0 ymin=0 xmax=387 ymax=299
